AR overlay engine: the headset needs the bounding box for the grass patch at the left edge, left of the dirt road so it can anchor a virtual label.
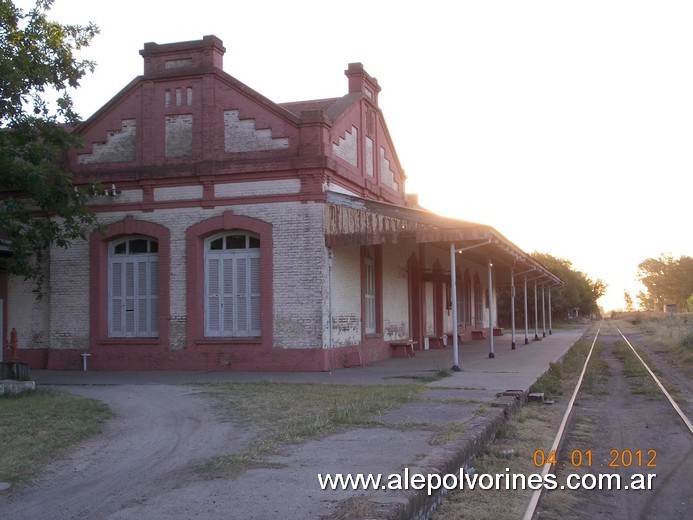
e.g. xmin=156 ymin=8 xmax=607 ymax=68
xmin=0 ymin=389 xmax=113 ymax=486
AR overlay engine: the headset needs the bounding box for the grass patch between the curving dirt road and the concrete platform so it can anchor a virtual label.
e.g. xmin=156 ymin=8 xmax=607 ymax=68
xmin=197 ymin=382 xmax=424 ymax=477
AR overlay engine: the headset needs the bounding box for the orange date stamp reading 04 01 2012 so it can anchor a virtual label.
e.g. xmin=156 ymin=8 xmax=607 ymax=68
xmin=532 ymin=449 xmax=657 ymax=468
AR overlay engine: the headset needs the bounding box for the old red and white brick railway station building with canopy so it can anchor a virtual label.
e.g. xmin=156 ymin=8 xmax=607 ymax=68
xmin=0 ymin=36 xmax=561 ymax=371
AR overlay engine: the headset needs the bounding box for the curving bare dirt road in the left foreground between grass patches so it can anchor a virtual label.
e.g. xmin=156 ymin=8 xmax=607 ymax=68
xmin=0 ymin=385 xmax=252 ymax=520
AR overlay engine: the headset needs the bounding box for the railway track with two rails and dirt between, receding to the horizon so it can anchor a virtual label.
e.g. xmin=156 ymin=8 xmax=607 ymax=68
xmin=524 ymin=321 xmax=693 ymax=520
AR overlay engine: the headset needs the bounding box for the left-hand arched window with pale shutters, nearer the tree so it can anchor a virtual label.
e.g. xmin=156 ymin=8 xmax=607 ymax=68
xmin=108 ymin=236 xmax=159 ymax=338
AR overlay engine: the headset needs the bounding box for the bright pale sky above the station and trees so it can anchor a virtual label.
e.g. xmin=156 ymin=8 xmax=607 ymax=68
xmin=39 ymin=0 xmax=693 ymax=311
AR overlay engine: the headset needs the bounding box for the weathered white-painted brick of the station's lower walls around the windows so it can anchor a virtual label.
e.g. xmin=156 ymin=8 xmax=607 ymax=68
xmin=17 ymin=197 xmax=485 ymax=356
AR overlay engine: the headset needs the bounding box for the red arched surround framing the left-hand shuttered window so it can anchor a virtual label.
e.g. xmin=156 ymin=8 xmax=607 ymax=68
xmin=89 ymin=216 xmax=171 ymax=348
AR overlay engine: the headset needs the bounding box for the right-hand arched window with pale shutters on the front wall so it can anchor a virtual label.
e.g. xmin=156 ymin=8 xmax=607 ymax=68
xmin=205 ymin=232 xmax=261 ymax=337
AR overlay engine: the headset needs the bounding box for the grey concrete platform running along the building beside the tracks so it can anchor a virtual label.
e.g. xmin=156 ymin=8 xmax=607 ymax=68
xmin=13 ymin=326 xmax=587 ymax=520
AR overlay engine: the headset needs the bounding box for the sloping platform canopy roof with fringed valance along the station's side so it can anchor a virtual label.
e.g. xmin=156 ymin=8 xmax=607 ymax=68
xmin=325 ymin=191 xmax=563 ymax=286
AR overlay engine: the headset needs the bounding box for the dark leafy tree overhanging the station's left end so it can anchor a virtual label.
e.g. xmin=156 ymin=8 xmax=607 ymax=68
xmin=0 ymin=0 xmax=98 ymax=278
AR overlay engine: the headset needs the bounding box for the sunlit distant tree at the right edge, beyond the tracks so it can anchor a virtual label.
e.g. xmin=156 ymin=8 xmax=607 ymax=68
xmin=638 ymin=254 xmax=693 ymax=311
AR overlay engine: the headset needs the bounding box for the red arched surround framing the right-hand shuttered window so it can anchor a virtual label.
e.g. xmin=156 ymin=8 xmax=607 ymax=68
xmin=186 ymin=211 xmax=274 ymax=350
